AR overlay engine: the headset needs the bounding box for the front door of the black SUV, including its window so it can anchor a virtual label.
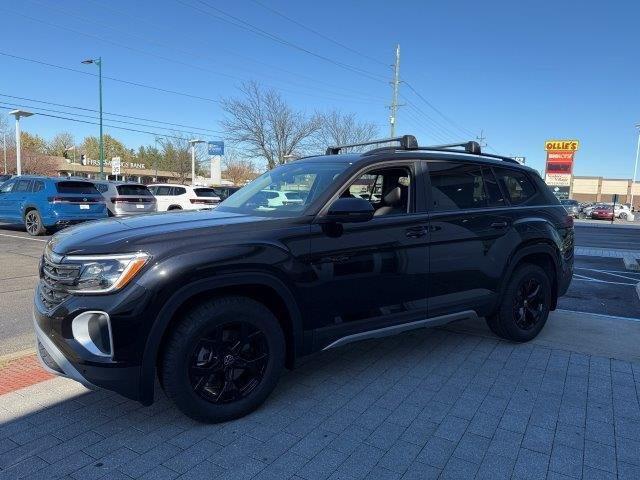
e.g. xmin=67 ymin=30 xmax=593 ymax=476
xmin=306 ymin=162 xmax=429 ymax=348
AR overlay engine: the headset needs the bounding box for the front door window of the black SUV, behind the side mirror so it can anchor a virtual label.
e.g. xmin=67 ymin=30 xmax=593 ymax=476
xmin=341 ymin=167 xmax=413 ymax=217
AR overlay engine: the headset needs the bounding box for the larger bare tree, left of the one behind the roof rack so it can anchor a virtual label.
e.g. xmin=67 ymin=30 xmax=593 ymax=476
xmin=222 ymin=82 xmax=320 ymax=169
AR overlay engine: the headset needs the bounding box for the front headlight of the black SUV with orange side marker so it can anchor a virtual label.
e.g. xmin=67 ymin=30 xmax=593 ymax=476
xmin=64 ymin=253 xmax=149 ymax=293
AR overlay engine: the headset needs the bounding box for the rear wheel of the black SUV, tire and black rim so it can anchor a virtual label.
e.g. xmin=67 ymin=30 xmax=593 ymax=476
xmin=486 ymin=263 xmax=552 ymax=342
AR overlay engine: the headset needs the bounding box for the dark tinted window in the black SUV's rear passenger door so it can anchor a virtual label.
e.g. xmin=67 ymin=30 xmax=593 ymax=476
xmin=429 ymin=161 xmax=504 ymax=211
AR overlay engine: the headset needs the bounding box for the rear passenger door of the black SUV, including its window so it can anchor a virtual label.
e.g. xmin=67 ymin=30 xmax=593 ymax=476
xmin=425 ymin=160 xmax=513 ymax=316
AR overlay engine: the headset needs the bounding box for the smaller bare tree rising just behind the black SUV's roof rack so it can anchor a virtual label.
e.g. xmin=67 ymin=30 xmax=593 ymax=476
xmin=314 ymin=110 xmax=378 ymax=151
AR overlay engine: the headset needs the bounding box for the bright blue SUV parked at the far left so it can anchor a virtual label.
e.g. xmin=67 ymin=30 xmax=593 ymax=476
xmin=0 ymin=176 xmax=107 ymax=235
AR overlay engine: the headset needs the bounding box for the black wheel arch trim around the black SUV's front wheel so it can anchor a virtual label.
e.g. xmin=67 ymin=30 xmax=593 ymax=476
xmin=140 ymin=272 xmax=303 ymax=405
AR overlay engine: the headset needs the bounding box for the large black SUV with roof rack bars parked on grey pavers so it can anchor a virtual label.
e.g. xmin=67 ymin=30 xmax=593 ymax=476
xmin=34 ymin=135 xmax=574 ymax=422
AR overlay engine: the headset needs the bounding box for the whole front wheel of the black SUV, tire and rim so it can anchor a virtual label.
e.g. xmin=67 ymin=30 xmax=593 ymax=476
xmin=159 ymin=297 xmax=285 ymax=423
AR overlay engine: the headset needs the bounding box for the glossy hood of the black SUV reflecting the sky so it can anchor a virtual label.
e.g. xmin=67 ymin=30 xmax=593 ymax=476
xmin=49 ymin=210 xmax=277 ymax=255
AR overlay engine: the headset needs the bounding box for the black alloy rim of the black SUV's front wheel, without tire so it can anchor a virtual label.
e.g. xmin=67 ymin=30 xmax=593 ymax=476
xmin=189 ymin=322 xmax=269 ymax=404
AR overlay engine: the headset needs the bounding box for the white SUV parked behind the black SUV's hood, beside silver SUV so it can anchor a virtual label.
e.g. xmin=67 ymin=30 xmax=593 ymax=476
xmin=149 ymin=183 xmax=220 ymax=212
